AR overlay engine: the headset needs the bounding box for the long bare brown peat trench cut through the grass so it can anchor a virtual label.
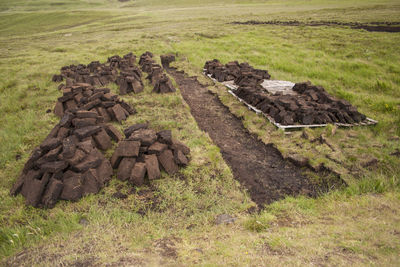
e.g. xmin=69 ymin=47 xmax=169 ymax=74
xmin=168 ymin=68 xmax=316 ymax=206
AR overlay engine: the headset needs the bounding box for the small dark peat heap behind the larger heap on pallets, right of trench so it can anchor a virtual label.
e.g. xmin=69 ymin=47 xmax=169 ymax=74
xmin=204 ymin=59 xmax=271 ymax=84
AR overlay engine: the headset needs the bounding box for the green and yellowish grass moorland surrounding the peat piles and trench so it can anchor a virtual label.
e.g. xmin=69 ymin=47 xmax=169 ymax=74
xmin=0 ymin=0 xmax=400 ymax=266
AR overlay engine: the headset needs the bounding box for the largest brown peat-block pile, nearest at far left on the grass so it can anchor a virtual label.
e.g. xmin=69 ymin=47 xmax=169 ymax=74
xmin=11 ymin=110 xmax=121 ymax=208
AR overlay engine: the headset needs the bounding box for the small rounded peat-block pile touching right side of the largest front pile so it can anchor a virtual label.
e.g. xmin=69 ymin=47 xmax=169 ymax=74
xmin=111 ymin=124 xmax=190 ymax=186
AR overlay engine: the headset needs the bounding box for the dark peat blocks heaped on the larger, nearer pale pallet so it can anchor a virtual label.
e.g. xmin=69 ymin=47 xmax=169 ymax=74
xmin=235 ymin=82 xmax=366 ymax=125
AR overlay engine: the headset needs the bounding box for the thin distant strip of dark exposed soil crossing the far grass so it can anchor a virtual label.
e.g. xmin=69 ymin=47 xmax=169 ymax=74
xmin=231 ymin=20 xmax=400 ymax=32
